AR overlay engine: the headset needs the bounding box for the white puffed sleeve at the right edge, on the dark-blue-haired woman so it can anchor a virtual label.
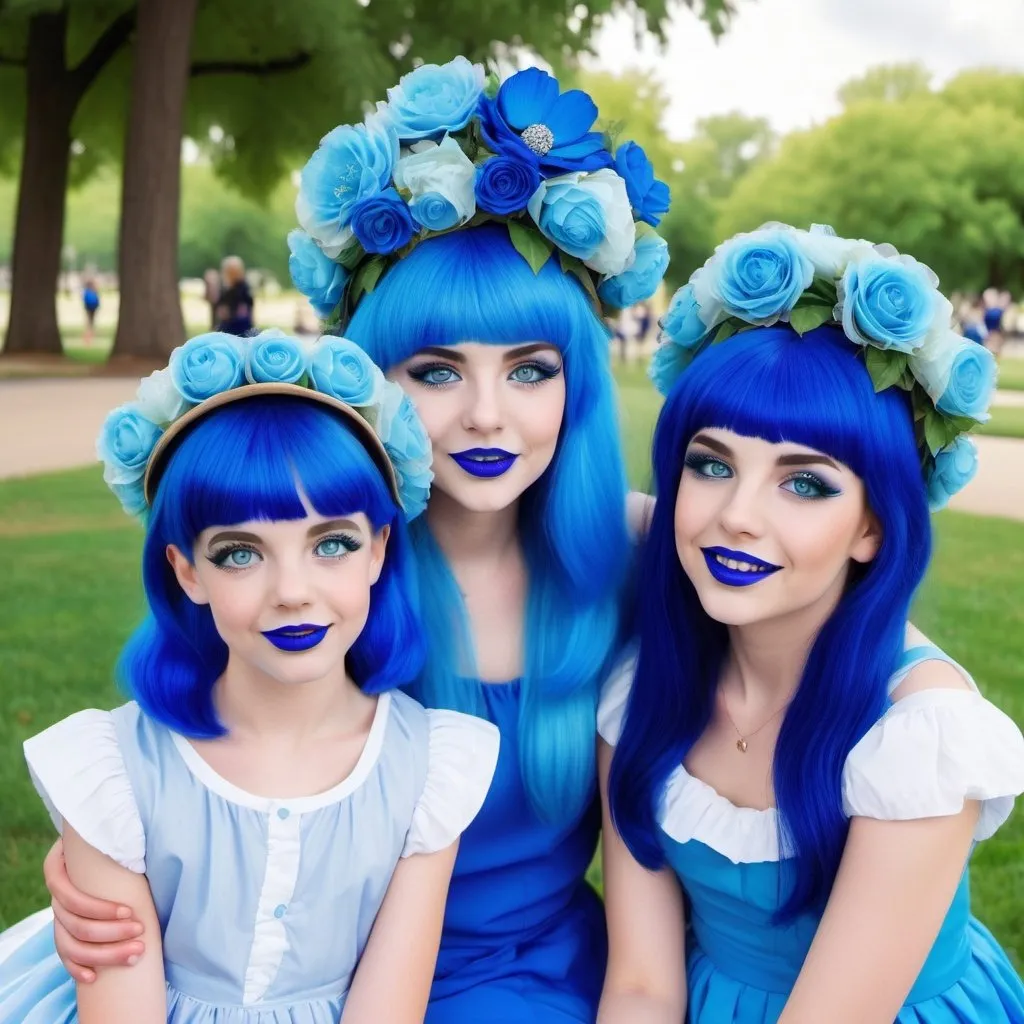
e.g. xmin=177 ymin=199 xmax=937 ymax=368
xmin=843 ymin=689 xmax=1024 ymax=841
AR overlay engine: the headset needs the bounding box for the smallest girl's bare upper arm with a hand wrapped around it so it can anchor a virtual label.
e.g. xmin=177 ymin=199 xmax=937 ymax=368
xmin=65 ymin=826 xmax=167 ymax=1024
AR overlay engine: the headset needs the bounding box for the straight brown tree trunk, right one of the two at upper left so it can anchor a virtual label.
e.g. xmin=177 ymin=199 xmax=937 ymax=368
xmin=111 ymin=0 xmax=199 ymax=358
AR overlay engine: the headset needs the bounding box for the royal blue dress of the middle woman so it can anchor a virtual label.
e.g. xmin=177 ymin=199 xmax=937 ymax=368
xmin=425 ymin=682 xmax=607 ymax=1024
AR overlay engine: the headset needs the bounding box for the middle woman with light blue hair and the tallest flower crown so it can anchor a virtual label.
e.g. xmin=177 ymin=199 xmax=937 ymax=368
xmin=39 ymin=58 xmax=668 ymax=1024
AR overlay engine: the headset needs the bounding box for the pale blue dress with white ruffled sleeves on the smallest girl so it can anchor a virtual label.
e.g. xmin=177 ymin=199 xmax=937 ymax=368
xmin=0 ymin=691 xmax=499 ymax=1024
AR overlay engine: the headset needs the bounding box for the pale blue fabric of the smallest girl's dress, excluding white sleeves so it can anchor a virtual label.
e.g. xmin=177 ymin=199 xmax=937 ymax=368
xmin=0 ymin=692 xmax=429 ymax=1024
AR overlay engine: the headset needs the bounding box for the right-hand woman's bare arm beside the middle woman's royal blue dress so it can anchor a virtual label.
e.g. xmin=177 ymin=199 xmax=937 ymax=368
xmin=597 ymin=740 xmax=686 ymax=1024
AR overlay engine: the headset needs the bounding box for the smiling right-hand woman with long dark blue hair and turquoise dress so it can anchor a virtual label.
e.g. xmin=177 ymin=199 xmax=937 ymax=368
xmin=598 ymin=227 xmax=1024 ymax=1024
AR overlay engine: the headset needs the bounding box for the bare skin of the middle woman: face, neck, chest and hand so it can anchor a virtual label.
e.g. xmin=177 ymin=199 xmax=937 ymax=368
xmin=44 ymin=342 xmax=565 ymax=970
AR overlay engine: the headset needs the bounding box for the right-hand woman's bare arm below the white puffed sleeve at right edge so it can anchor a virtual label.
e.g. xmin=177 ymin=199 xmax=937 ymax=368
xmin=779 ymin=801 xmax=979 ymax=1024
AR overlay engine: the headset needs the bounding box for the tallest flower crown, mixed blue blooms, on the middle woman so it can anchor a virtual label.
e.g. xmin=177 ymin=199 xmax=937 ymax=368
xmin=288 ymin=56 xmax=669 ymax=327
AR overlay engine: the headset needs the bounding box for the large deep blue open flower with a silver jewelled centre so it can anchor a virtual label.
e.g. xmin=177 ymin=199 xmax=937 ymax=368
xmin=480 ymin=68 xmax=612 ymax=177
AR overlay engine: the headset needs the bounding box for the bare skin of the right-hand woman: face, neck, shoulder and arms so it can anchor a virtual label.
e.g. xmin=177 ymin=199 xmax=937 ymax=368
xmin=599 ymin=429 xmax=978 ymax=1024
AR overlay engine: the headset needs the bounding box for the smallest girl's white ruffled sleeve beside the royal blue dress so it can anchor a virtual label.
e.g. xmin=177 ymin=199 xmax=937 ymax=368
xmin=401 ymin=709 xmax=501 ymax=857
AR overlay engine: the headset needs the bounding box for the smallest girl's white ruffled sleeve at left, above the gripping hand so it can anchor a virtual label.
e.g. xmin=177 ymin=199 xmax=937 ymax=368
xmin=25 ymin=710 xmax=145 ymax=874
